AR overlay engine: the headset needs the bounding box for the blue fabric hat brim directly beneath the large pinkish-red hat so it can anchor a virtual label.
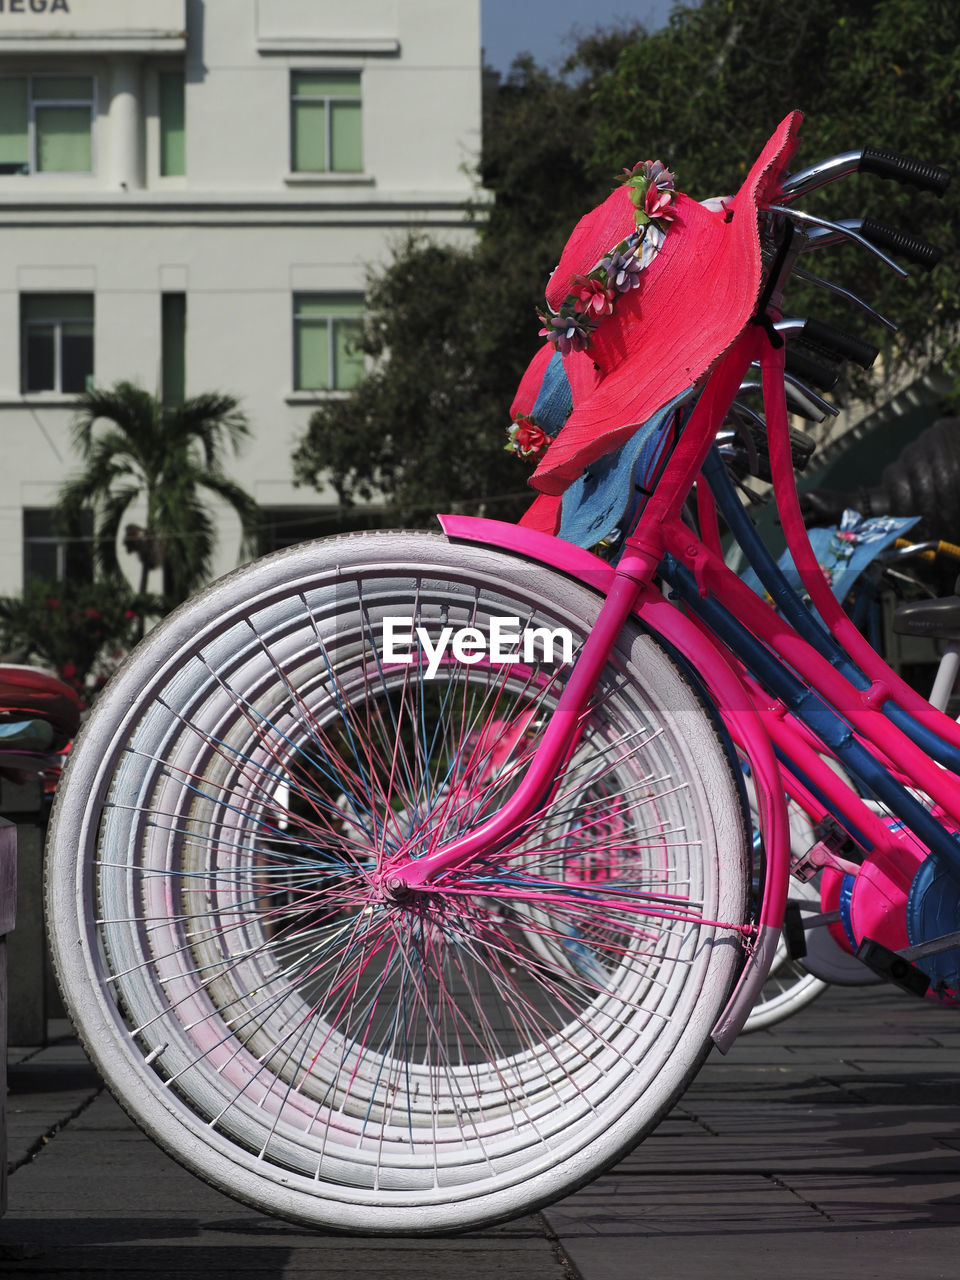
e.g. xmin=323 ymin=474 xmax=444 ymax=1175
xmin=555 ymin=392 xmax=687 ymax=547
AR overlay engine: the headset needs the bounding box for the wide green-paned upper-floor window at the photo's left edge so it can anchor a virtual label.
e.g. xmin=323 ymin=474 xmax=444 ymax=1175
xmin=0 ymin=76 xmax=93 ymax=174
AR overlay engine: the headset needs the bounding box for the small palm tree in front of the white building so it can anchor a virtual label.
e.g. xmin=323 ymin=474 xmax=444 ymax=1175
xmin=58 ymin=381 xmax=260 ymax=605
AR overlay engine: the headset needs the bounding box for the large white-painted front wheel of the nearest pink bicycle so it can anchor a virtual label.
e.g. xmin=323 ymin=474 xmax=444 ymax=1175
xmin=47 ymin=534 xmax=749 ymax=1233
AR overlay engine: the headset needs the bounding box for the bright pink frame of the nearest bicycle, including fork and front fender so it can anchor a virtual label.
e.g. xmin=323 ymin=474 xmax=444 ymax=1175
xmin=384 ymin=307 xmax=960 ymax=1029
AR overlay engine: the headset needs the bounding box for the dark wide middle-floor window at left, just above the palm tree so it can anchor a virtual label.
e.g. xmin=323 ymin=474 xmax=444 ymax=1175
xmin=20 ymin=293 xmax=93 ymax=394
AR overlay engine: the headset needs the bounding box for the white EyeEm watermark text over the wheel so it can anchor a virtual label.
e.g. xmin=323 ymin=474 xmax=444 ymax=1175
xmin=383 ymin=617 xmax=573 ymax=680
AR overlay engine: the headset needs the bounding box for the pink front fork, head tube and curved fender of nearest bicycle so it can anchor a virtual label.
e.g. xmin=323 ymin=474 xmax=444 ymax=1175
xmin=384 ymin=326 xmax=790 ymax=1048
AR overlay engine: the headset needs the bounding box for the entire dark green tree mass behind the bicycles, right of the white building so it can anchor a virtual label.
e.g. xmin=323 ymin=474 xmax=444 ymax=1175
xmin=294 ymin=0 xmax=960 ymax=524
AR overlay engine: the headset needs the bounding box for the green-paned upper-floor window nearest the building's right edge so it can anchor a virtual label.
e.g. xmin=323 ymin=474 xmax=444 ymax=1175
xmin=291 ymin=72 xmax=364 ymax=173
